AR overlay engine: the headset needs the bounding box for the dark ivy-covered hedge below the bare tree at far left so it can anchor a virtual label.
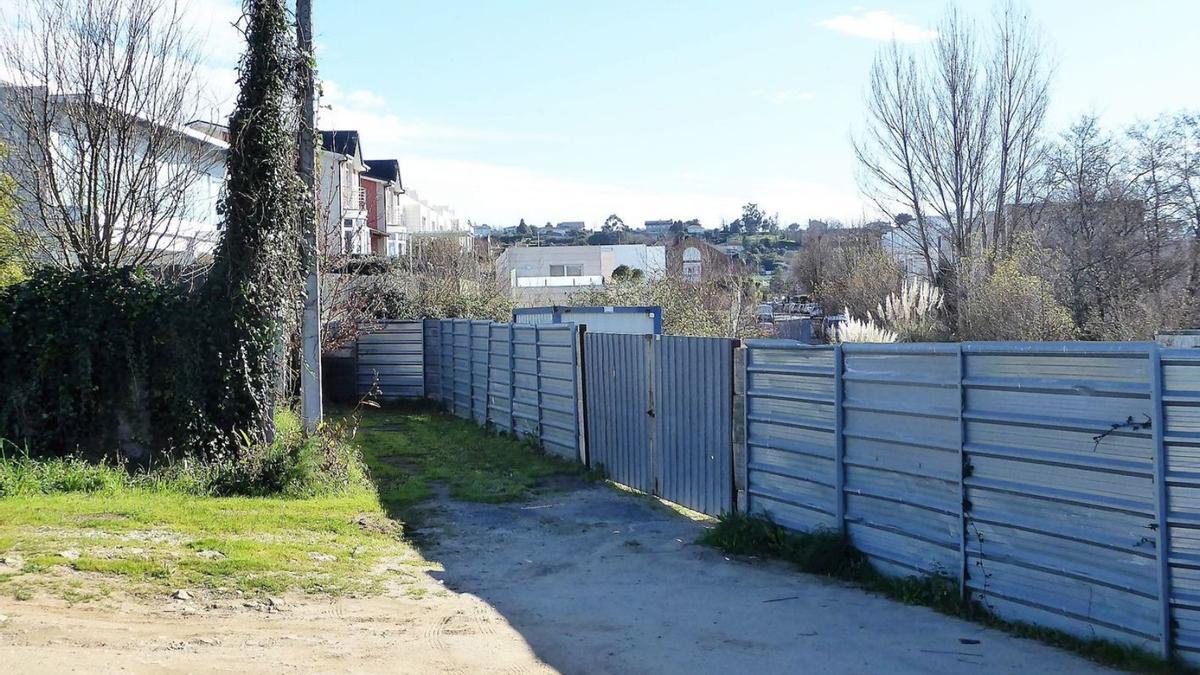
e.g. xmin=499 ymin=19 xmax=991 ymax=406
xmin=0 ymin=268 xmax=203 ymax=461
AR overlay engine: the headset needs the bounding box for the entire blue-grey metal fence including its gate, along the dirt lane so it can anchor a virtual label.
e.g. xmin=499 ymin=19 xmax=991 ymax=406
xmin=355 ymin=319 xmax=1200 ymax=662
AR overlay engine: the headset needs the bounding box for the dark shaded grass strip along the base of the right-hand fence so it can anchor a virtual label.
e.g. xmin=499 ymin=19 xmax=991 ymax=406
xmin=700 ymin=514 xmax=1185 ymax=674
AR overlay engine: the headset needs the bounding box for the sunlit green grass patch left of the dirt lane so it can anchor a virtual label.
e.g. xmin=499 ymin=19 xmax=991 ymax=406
xmin=0 ymin=489 xmax=431 ymax=597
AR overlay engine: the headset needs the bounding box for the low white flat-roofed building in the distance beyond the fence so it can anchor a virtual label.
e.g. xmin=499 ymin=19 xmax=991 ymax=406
xmin=496 ymin=244 xmax=666 ymax=304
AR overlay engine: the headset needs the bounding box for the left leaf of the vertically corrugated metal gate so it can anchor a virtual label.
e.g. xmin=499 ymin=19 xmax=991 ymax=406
xmin=583 ymin=333 xmax=654 ymax=492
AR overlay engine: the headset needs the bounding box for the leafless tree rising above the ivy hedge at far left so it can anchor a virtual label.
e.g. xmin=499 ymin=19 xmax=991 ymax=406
xmin=0 ymin=0 xmax=214 ymax=269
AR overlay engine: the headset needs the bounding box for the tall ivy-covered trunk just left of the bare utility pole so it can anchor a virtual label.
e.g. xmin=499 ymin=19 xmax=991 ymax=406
xmin=204 ymin=0 xmax=305 ymax=455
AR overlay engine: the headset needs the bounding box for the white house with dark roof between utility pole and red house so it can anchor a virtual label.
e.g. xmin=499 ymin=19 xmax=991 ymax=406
xmin=317 ymin=131 xmax=372 ymax=255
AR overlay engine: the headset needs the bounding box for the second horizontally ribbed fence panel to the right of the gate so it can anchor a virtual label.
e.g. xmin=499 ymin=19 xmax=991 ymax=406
xmin=841 ymin=345 xmax=962 ymax=578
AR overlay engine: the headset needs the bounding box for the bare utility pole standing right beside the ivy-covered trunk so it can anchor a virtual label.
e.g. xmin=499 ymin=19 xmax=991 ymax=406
xmin=296 ymin=0 xmax=322 ymax=432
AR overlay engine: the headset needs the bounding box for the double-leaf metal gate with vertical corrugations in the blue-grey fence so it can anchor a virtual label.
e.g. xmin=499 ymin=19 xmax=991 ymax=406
xmin=583 ymin=333 xmax=734 ymax=515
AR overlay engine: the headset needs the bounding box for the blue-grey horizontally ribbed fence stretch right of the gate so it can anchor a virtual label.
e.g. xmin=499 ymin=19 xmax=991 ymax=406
xmin=745 ymin=341 xmax=1180 ymax=653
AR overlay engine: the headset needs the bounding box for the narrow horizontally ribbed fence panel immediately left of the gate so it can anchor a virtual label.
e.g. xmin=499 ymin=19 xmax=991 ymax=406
xmin=533 ymin=324 xmax=580 ymax=460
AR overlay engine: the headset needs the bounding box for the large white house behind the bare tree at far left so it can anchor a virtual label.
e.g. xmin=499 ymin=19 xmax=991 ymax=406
xmin=0 ymin=83 xmax=229 ymax=265
